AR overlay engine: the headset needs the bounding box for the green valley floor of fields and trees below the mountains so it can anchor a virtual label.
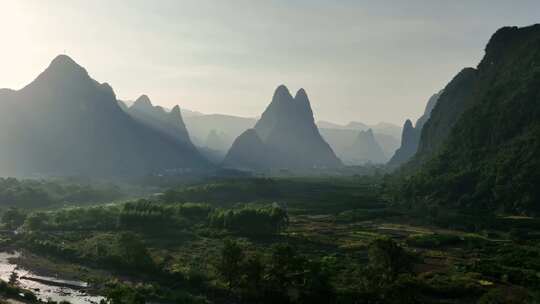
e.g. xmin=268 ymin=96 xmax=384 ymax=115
xmin=4 ymin=178 xmax=540 ymax=303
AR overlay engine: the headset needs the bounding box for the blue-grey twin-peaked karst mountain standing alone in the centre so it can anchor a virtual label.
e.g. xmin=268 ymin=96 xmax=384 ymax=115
xmin=224 ymin=85 xmax=341 ymax=169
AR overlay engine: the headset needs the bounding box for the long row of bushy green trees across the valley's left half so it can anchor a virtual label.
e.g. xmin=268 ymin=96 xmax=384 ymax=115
xmin=2 ymin=200 xmax=288 ymax=235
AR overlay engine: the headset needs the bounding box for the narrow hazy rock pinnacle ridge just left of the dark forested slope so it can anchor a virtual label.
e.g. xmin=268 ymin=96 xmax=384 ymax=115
xmin=388 ymin=91 xmax=442 ymax=168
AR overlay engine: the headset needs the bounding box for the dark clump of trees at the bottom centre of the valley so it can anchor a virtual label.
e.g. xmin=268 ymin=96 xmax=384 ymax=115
xmin=217 ymin=240 xmax=335 ymax=303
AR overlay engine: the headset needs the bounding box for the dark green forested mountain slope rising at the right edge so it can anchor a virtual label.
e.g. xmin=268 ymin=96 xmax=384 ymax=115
xmin=406 ymin=25 xmax=540 ymax=214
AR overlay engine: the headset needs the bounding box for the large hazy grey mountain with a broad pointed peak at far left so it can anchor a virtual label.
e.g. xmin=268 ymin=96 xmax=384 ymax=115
xmin=0 ymin=55 xmax=208 ymax=176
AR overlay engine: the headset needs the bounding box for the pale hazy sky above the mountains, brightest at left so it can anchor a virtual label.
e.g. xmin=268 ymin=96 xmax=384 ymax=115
xmin=0 ymin=0 xmax=540 ymax=125
